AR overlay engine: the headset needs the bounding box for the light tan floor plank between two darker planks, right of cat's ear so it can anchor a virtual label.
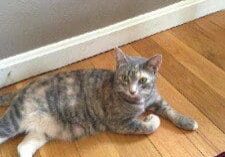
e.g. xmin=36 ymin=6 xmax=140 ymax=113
xmin=151 ymin=31 xmax=225 ymax=98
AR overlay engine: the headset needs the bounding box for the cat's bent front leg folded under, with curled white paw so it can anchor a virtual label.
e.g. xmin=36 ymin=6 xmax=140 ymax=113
xmin=110 ymin=114 xmax=160 ymax=134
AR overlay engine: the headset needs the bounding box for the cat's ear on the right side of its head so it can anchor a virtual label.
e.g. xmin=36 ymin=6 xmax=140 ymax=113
xmin=144 ymin=54 xmax=162 ymax=73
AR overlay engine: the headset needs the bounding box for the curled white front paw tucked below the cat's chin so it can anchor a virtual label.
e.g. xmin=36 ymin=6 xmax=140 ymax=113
xmin=143 ymin=114 xmax=160 ymax=133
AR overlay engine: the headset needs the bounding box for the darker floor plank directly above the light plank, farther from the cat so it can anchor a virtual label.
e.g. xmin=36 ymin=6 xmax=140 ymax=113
xmin=171 ymin=19 xmax=225 ymax=70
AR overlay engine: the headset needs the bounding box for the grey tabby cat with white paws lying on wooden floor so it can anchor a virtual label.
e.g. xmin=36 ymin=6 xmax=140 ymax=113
xmin=0 ymin=48 xmax=198 ymax=157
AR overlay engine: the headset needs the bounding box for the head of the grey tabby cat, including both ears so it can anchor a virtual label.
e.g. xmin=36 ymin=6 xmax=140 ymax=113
xmin=114 ymin=48 xmax=162 ymax=104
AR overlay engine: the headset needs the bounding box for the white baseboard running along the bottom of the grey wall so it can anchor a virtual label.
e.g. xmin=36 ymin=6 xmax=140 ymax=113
xmin=0 ymin=0 xmax=225 ymax=87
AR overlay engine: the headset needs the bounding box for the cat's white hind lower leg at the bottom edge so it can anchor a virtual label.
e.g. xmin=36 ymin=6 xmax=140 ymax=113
xmin=17 ymin=132 xmax=48 ymax=157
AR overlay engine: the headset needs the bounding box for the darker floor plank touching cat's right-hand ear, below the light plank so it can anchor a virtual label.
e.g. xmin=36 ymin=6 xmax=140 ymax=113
xmin=132 ymin=37 xmax=225 ymax=132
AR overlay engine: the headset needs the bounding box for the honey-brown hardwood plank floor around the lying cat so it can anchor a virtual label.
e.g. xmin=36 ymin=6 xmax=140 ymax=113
xmin=0 ymin=11 xmax=225 ymax=157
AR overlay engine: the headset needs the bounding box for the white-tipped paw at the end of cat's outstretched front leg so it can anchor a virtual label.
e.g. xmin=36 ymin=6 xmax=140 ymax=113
xmin=178 ymin=117 xmax=198 ymax=131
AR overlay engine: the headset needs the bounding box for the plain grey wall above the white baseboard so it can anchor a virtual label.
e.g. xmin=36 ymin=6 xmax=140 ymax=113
xmin=0 ymin=0 xmax=180 ymax=59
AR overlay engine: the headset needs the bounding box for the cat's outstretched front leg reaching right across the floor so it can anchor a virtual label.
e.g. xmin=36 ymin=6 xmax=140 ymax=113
xmin=148 ymin=95 xmax=198 ymax=130
